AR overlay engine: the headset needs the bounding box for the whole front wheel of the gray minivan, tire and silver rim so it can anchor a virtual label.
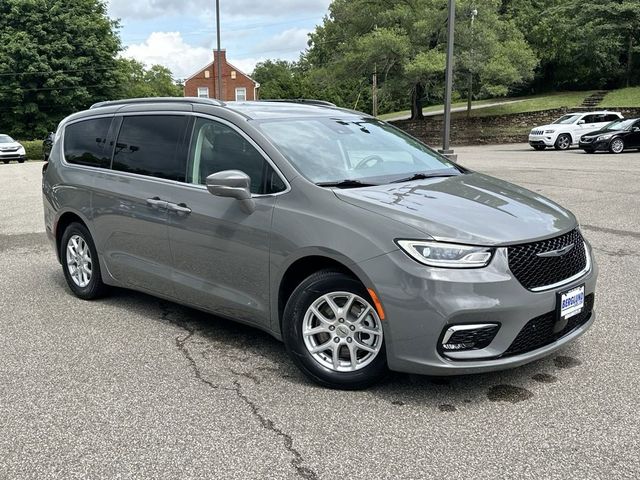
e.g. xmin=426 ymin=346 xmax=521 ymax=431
xmin=282 ymin=270 xmax=387 ymax=390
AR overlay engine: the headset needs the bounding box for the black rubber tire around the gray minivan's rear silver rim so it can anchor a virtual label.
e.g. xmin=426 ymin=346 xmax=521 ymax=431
xmin=60 ymin=222 xmax=108 ymax=300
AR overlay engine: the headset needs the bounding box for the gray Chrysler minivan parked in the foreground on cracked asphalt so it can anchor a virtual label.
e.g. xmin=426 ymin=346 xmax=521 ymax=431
xmin=43 ymin=98 xmax=597 ymax=389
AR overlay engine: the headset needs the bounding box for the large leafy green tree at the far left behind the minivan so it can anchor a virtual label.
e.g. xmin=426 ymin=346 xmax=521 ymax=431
xmin=0 ymin=0 xmax=121 ymax=138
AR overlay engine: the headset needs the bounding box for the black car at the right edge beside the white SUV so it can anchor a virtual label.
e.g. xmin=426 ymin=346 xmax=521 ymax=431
xmin=580 ymin=118 xmax=640 ymax=153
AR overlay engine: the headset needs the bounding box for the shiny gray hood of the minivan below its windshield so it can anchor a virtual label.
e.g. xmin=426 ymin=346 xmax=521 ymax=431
xmin=335 ymin=173 xmax=577 ymax=246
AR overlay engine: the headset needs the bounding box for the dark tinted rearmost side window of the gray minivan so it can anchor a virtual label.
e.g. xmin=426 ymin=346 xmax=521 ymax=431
xmin=64 ymin=118 xmax=111 ymax=168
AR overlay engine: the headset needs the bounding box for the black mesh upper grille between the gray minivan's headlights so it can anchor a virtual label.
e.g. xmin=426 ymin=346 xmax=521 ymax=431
xmin=507 ymin=228 xmax=587 ymax=290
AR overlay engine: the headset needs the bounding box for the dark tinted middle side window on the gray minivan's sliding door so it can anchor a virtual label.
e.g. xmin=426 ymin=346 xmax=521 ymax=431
xmin=113 ymin=115 xmax=188 ymax=181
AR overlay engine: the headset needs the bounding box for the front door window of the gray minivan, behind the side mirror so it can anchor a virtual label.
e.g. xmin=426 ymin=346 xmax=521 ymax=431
xmin=187 ymin=118 xmax=285 ymax=194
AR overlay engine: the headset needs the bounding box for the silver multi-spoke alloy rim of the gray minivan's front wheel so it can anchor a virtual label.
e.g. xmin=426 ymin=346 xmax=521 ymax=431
xmin=302 ymin=292 xmax=383 ymax=372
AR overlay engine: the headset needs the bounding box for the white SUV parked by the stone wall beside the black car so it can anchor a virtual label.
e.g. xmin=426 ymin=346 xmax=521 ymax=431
xmin=529 ymin=110 xmax=623 ymax=150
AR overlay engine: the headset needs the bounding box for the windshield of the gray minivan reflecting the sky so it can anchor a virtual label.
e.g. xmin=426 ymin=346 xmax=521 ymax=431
xmin=251 ymin=117 xmax=460 ymax=184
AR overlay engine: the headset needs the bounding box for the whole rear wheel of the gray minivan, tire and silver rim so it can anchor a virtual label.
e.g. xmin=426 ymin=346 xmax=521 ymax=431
xmin=60 ymin=223 xmax=107 ymax=300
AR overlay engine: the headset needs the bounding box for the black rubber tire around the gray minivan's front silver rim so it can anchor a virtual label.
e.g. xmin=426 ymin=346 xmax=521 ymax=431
xmin=282 ymin=270 xmax=388 ymax=390
